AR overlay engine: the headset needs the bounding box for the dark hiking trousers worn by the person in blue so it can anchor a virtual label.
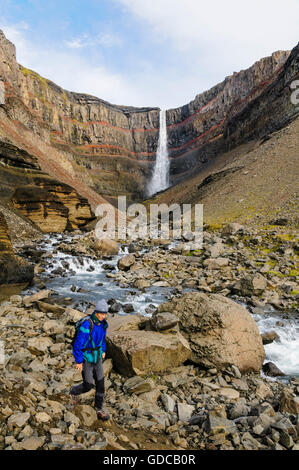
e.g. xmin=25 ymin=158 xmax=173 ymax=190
xmin=71 ymin=359 xmax=105 ymax=410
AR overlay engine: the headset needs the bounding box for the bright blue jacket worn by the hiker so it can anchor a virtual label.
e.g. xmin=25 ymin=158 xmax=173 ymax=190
xmin=73 ymin=320 xmax=108 ymax=364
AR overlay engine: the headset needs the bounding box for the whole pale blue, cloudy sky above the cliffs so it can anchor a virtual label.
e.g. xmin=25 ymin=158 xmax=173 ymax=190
xmin=0 ymin=0 xmax=299 ymax=109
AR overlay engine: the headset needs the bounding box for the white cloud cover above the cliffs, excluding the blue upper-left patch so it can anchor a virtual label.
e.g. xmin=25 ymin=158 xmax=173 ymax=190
xmin=0 ymin=0 xmax=299 ymax=109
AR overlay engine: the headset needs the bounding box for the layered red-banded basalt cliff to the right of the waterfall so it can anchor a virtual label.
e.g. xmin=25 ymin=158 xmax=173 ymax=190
xmin=167 ymin=49 xmax=298 ymax=183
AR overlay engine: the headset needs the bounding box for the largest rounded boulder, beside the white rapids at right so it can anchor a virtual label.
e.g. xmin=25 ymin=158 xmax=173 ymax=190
xmin=158 ymin=292 xmax=265 ymax=372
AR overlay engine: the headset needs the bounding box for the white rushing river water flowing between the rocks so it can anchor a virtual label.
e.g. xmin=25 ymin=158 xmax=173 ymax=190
xmin=23 ymin=234 xmax=299 ymax=380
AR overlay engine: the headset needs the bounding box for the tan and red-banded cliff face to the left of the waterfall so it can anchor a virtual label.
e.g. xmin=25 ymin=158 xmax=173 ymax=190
xmin=0 ymin=28 xmax=159 ymax=209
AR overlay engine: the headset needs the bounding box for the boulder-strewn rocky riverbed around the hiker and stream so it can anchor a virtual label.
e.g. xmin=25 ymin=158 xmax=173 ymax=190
xmin=0 ymin=224 xmax=299 ymax=450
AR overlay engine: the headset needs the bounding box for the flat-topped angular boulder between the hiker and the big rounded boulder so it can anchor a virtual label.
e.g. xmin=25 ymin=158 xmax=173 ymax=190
xmin=106 ymin=315 xmax=191 ymax=377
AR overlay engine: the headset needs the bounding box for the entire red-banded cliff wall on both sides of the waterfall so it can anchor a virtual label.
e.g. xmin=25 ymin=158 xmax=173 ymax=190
xmin=0 ymin=32 xmax=298 ymax=209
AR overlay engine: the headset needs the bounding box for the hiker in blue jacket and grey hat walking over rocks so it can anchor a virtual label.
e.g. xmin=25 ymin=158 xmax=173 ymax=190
xmin=70 ymin=299 xmax=109 ymax=421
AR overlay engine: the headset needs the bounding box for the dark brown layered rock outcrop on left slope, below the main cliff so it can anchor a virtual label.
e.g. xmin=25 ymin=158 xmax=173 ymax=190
xmin=0 ymin=137 xmax=93 ymax=232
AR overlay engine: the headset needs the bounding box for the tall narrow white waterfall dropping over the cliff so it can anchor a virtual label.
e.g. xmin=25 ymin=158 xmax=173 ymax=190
xmin=147 ymin=111 xmax=170 ymax=196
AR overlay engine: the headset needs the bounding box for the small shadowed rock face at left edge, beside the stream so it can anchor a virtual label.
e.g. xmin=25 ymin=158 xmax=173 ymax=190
xmin=0 ymin=212 xmax=34 ymax=285
